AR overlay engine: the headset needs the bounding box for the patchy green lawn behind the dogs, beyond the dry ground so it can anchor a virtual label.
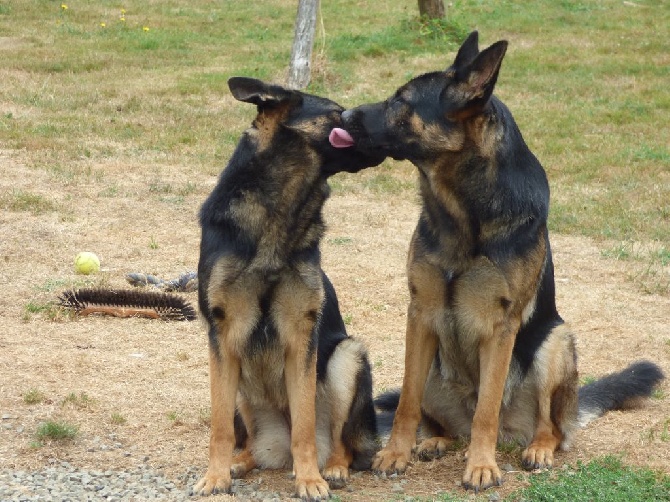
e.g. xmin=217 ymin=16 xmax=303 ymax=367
xmin=0 ymin=0 xmax=670 ymax=251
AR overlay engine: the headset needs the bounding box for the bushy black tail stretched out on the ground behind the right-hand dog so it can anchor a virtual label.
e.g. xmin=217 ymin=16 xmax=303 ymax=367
xmin=578 ymin=361 xmax=665 ymax=427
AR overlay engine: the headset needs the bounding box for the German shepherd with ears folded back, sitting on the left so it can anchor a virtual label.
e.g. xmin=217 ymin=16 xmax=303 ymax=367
xmin=194 ymin=77 xmax=384 ymax=500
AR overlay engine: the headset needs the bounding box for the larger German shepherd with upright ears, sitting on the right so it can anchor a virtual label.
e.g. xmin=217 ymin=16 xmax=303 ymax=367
xmin=331 ymin=32 xmax=663 ymax=491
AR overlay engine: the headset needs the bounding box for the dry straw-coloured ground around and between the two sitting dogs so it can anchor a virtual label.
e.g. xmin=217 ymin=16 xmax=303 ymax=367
xmin=0 ymin=152 xmax=670 ymax=500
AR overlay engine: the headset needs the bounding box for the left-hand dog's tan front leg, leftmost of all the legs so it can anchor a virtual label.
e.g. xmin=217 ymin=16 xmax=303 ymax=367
xmin=194 ymin=345 xmax=240 ymax=495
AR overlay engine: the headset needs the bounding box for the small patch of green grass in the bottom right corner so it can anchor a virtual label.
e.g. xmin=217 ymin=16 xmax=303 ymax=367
xmin=507 ymin=456 xmax=670 ymax=502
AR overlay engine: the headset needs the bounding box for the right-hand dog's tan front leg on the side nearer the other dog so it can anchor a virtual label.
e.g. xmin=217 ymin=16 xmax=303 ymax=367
xmin=372 ymin=263 xmax=446 ymax=474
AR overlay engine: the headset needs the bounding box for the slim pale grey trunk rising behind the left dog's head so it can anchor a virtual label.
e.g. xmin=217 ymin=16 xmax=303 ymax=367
xmin=288 ymin=0 xmax=322 ymax=89
